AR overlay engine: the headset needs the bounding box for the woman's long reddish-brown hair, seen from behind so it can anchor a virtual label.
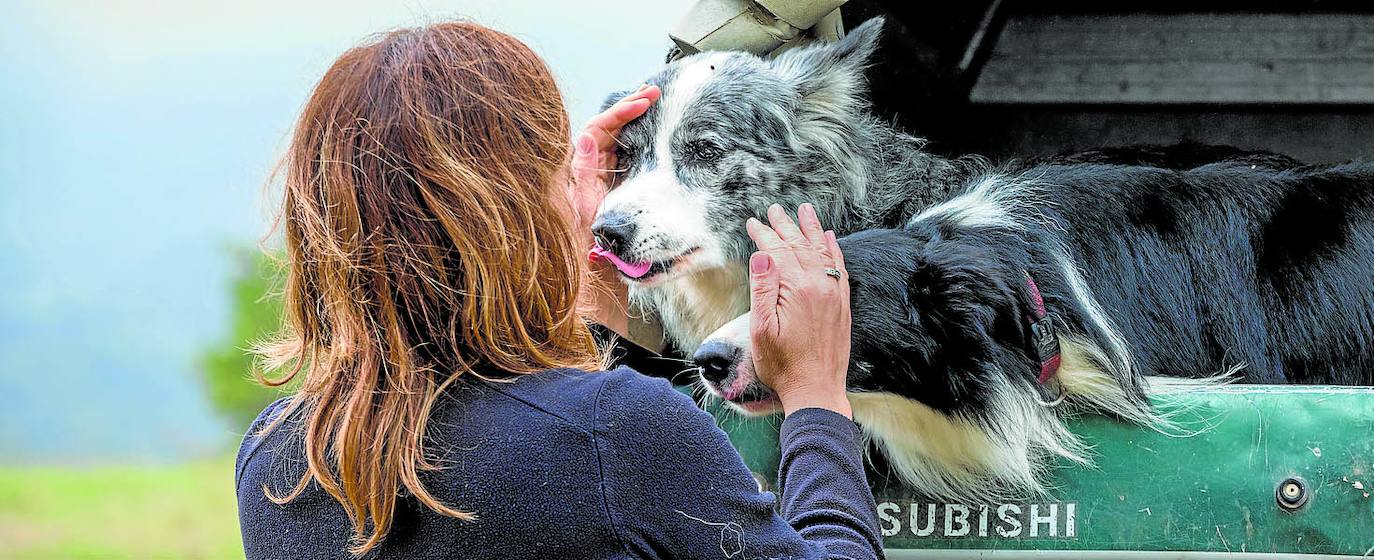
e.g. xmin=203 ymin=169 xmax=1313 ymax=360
xmin=261 ymin=22 xmax=598 ymax=553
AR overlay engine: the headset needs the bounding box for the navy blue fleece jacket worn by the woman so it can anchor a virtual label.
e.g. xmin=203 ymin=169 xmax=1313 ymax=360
xmin=236 ymin=368 xmax=882 ymax=560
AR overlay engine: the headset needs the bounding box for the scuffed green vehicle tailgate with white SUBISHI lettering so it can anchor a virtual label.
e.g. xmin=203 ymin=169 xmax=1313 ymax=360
xmin=710 ymin=386 xmax=1374 ymax=557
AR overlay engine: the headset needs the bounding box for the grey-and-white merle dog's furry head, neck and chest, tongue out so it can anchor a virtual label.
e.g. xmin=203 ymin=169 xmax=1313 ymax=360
xmin=598 ymin=21 xmax=966 ymax=355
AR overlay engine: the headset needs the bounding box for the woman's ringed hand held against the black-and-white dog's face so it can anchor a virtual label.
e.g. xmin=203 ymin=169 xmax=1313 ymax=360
xmin=746 ymin=205 xmax=853 ymax=417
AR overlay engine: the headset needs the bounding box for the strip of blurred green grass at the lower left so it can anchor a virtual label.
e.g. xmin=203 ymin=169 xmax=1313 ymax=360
xmin=0 ymin=457 xmax=243 ymax=560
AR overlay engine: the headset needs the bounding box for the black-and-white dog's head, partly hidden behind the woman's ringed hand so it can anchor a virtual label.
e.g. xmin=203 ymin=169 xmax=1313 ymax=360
xmin=694 ymin=223 xmax=1039 ymax=415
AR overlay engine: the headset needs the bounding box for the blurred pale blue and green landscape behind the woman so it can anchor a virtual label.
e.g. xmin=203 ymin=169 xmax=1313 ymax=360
xmin=0 ymin=0 xmax=688 ymax=559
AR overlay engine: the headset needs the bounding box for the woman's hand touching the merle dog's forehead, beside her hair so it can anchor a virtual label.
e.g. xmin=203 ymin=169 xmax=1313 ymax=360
xmin=567 ymin=85 xmax=662 ymax=336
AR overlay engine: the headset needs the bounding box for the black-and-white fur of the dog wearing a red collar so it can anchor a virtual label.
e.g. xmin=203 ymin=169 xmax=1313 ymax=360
xmin=702 ymin=161 xmax=1374 ymax=500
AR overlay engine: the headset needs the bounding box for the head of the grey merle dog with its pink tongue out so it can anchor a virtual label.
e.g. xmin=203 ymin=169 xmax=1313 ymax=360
xmin=592 ymin=21 xmax=882 ymax=285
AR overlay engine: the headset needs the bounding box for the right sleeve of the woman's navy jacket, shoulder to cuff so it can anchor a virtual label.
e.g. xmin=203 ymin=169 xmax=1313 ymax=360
xmin=594 ymin=369 xmax=882 ymax=559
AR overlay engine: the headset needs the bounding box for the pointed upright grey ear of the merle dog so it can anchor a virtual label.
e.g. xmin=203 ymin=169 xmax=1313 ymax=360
xmin=772 ymin=18 xmax=883 ymax=111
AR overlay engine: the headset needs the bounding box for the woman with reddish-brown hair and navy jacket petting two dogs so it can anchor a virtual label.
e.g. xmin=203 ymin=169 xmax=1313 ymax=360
xmin=236 ymin=23 xmax=882 ymax=559
